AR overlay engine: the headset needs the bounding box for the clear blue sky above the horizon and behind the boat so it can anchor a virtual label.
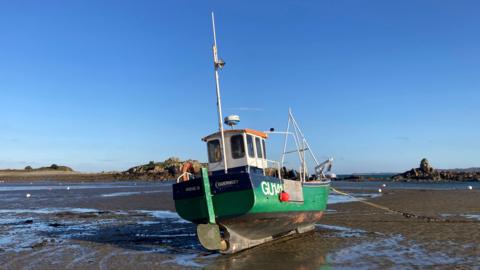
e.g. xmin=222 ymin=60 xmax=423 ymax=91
xmin=0 ymin=0 xmax=480 ymax=173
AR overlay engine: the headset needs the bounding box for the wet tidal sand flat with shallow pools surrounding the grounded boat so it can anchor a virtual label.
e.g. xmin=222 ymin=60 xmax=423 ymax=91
xmin=0 ymin=182 xmax=480 ymax=269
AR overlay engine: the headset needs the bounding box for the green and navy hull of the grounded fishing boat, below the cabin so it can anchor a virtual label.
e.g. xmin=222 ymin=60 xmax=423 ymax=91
xmin=174 ymin=173 xmax=330 ymax=253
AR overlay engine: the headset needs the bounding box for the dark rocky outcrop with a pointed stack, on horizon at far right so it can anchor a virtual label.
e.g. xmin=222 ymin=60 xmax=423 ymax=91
xmin=392 ymin=158 xmax=480 ymax=182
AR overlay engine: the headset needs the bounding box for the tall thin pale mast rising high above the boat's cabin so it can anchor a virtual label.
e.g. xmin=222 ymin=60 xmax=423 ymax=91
xmin=212 ymin=12 xmax=228 ymax=173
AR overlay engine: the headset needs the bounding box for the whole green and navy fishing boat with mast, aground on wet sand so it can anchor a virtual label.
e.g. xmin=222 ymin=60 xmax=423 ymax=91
xmin=173 ymin=13 xmax=333 ymax=254
